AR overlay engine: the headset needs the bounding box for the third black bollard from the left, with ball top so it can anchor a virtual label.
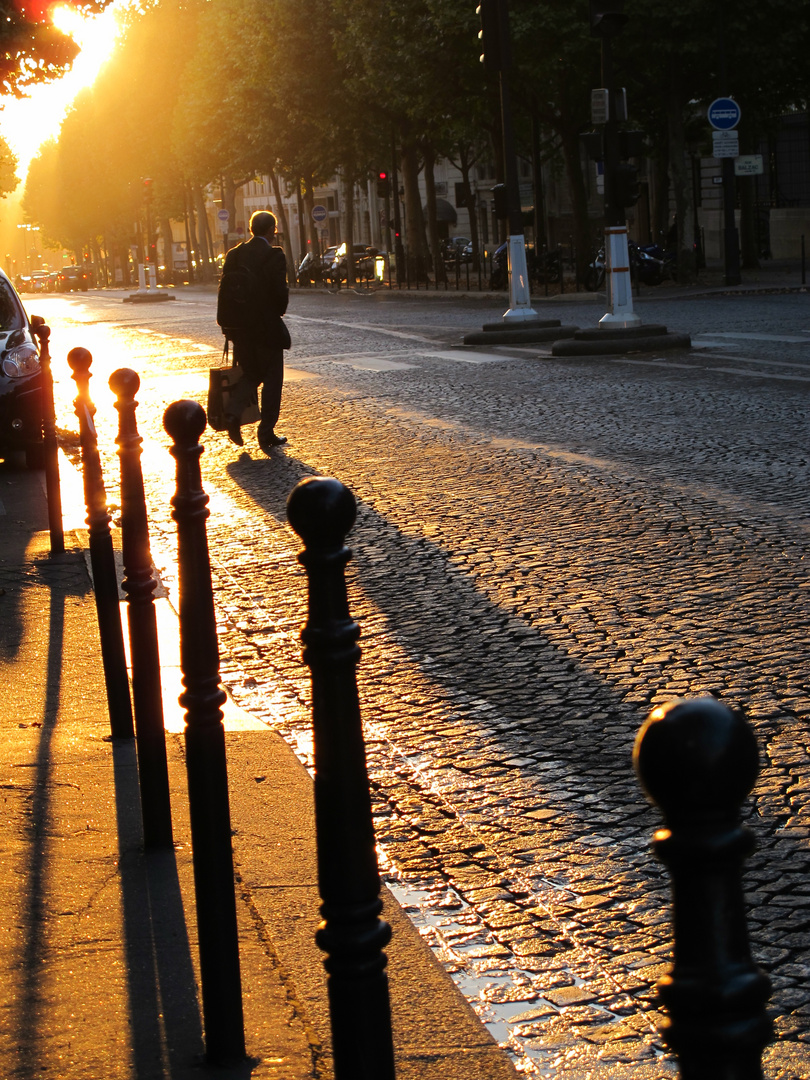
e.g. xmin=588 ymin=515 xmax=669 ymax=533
xmin=109 ymin=367 xmax=172 ymax=848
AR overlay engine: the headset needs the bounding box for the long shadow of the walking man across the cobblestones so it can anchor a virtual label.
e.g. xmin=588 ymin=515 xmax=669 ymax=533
xmin=223 ymin=453 xmax=658 ymax=816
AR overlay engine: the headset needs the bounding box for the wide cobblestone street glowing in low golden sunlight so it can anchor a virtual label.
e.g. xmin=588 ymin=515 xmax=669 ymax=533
xmin=41 ymin=295 xmax=810 ymax=1080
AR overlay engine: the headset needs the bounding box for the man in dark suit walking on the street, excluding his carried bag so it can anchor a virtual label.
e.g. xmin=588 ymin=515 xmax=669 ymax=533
xmin=217 ymin=210 xmax=291 ymax=454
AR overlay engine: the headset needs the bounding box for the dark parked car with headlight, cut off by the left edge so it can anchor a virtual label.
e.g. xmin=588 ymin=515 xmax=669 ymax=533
xmin=0 ymin=270 xmax=42 ymax=469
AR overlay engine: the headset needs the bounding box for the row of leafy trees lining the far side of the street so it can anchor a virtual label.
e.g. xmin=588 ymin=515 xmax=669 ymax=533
xmin=15 ymin=0 xmax=810 ymax=282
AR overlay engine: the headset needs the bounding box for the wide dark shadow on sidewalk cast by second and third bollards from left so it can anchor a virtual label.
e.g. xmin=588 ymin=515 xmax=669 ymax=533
xmin=112 ymin=739 xmax=204 ymax=1080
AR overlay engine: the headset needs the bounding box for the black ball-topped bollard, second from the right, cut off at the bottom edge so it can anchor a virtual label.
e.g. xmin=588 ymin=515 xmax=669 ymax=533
xmin=287 ymin=476 xmax=394 ymax=1080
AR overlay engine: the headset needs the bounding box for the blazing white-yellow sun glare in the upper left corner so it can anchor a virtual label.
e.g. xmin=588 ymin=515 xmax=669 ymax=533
xmin=0 ymin=3 xmax=121 ymax=180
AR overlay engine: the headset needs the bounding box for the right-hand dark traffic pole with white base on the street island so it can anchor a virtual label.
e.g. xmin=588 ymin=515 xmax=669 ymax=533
xmin=599 ymin=35 xmax=642 ymax=328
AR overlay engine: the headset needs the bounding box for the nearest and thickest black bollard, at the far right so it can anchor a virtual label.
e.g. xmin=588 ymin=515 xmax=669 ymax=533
xmin=633 ymin=698 xmax=772 ymax=1080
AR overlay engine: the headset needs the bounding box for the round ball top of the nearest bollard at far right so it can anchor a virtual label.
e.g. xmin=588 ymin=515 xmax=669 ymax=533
xmin=633 ymin=698 xmax=758 ymax=821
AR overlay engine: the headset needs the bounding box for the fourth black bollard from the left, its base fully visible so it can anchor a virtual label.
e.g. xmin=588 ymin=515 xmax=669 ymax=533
xmin=163 ymin=401 xmax=245 ymax=1064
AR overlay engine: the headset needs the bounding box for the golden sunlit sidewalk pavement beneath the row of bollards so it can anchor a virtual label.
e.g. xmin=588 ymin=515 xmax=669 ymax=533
xmin=0 ymin=464 xmax=516 ymax=1080
